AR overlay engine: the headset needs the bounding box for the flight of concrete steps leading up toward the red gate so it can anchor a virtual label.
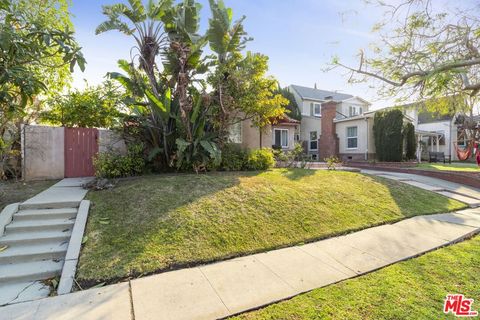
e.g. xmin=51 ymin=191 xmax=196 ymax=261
xmin=0 ymin=179 xmax=92 ymax=304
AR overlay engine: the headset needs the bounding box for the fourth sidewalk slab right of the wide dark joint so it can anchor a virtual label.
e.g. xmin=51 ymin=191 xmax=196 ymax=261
xmin=300 ymin=238 xmax=388 ymax=277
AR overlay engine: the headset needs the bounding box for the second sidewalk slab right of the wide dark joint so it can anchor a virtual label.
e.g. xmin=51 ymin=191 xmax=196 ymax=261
xmin=200 ymin=256 xmax=298 ymax=314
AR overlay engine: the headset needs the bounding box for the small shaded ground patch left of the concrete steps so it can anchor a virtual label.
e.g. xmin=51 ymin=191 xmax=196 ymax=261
xmin=0 ymin=181 xmax=57 ymax=211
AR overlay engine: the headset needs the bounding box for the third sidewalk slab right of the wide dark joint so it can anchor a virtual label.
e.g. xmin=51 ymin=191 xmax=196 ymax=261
xmin=255 ymin=247 xmax=351 ymax=293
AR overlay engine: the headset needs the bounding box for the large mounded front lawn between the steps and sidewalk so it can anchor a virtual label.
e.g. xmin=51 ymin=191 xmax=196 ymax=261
xmin=77 ymin=169 xmax=464 ymax=285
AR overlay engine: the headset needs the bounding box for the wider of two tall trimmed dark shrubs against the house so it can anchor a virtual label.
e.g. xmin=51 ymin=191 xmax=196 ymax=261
xmin=373 ymin=109 xmax=403 ymax=162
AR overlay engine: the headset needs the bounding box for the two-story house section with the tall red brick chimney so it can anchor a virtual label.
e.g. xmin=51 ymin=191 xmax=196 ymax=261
xmin=289 ymin=85 xmax=375 ymax=160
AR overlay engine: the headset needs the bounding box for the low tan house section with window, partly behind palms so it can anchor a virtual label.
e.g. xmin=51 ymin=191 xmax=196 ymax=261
xmin=230 ymin=116 xmax=300 ymax=151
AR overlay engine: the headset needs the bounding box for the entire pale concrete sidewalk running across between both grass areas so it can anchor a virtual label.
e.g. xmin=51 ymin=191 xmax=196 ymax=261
xmin=0 ymin=209 xmax=480 ymax=320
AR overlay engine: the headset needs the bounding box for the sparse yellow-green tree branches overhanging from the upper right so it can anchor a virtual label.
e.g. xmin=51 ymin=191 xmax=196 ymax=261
xmin=333 ymin=0 xmax=480 ymax=113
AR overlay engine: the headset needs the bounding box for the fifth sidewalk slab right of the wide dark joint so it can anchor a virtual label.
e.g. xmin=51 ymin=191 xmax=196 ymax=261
xmin=337 ymin=225 xmax=446 ymax=264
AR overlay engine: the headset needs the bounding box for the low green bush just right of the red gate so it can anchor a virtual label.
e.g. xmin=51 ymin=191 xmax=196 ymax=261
xmin=93 ymin=144 xmax=145 ymax=178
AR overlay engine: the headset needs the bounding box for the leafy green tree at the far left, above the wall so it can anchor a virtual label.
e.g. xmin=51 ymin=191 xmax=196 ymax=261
xmin=0 ymin=0 xmax=85 ymax=178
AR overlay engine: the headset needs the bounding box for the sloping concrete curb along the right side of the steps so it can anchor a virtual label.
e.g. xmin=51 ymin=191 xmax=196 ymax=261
xmin=57 ymin=200 xmax=90 ymax=295
